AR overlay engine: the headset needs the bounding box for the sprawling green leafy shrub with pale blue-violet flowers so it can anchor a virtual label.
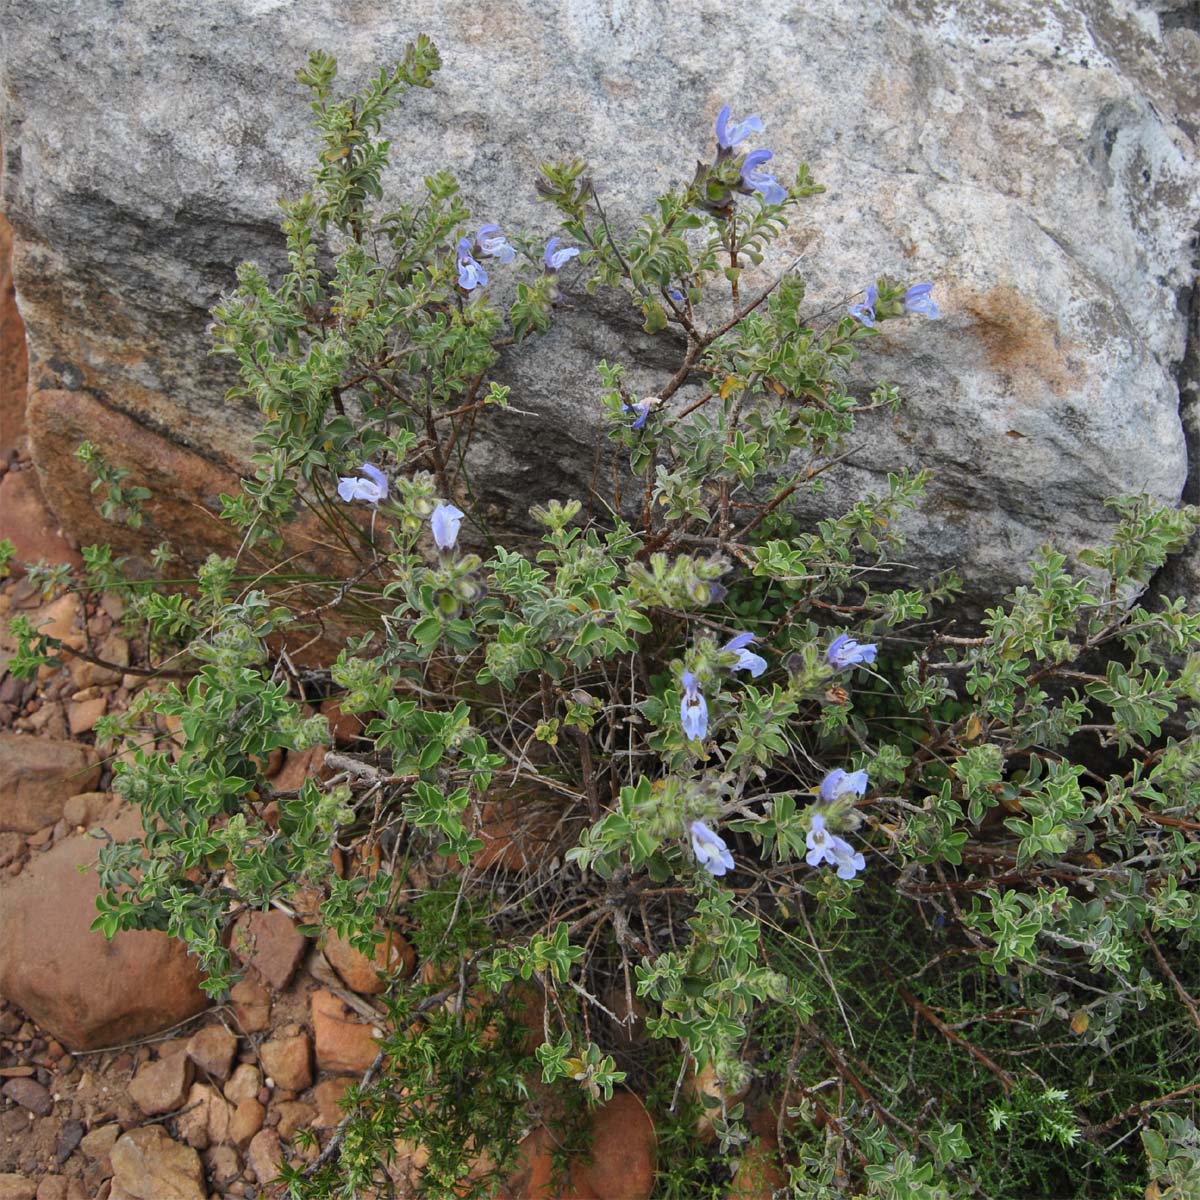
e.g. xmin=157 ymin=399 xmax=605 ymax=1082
xmin=16 ymin=38 xmax=1200 ymax=1198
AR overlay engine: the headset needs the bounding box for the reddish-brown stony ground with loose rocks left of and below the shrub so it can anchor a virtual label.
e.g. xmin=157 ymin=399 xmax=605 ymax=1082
xmin=0 ymin=456 xmax=691 ymax=1200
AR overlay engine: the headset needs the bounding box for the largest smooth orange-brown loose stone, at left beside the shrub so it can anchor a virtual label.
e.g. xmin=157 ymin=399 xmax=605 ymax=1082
xmin=0 ymin=811 xmax=208 ymax=1050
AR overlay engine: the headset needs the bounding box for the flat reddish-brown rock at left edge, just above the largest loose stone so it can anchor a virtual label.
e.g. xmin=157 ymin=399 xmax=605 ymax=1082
xmin=0 ymin=733 xmax=101 ymax=845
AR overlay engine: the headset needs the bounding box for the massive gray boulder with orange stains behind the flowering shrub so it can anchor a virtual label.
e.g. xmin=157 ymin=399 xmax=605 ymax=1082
xmin=0 ymin=0 xmax=1200 ymax=596
